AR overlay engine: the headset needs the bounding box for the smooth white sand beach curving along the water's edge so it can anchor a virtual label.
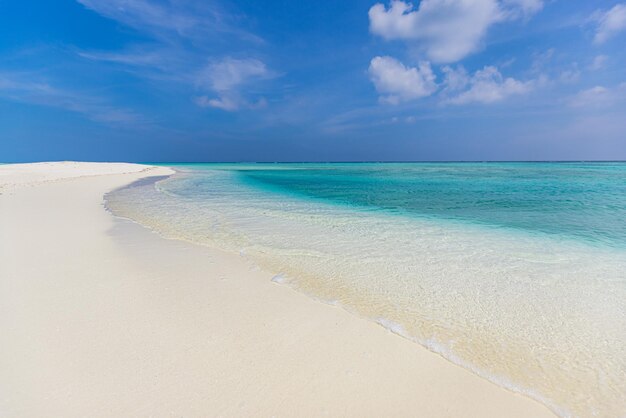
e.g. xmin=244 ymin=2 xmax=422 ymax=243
xmin=0 ymin=162 xmax=555 ymax=418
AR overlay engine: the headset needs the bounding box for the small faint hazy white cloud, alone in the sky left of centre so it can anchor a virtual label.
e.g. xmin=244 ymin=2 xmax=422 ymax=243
xmin=195 ymin=57 xmax=274 ymax=111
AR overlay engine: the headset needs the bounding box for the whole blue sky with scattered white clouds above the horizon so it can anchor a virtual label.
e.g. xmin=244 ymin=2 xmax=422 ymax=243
xmin=0 ymin=0 xmax=626 ymax=162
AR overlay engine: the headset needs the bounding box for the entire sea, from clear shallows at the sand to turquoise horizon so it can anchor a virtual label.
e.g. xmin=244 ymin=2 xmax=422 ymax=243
xmin=107 ymin=163 xmax=626 ymax=417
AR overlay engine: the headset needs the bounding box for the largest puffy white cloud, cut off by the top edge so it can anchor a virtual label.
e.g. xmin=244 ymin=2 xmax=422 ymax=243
xmin=369 ymin=0 xmax=543 ymax=63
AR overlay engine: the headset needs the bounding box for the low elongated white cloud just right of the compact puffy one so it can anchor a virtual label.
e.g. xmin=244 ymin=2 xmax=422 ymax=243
xmin=443 ymin=66 xmax=534 ymax=105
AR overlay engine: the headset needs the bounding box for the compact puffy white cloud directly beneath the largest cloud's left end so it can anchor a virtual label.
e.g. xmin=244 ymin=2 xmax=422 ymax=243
xmin=369 ymin=57 xmax=437 ymax=104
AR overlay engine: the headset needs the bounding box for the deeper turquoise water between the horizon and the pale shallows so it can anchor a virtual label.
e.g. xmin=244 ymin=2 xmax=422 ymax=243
xmin=171 ymin=163 xmax=626 ymax=246
